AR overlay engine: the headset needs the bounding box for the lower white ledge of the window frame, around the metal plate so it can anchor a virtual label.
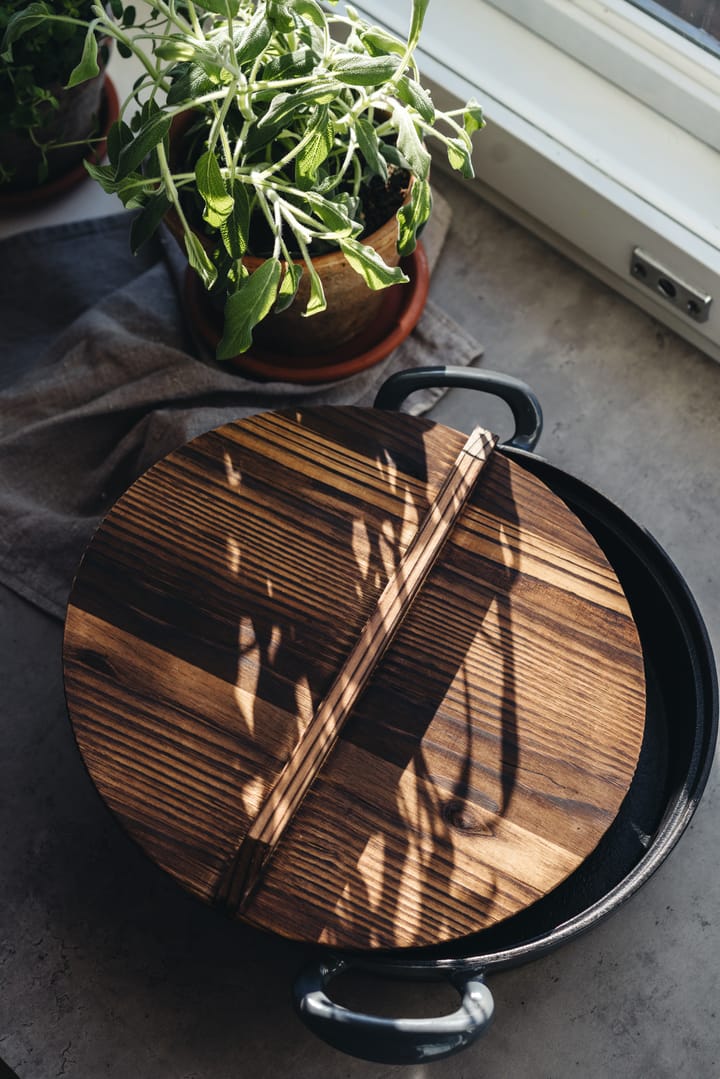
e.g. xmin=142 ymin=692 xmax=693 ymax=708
xmin=345 ymin=0 xmax=720 ymax=359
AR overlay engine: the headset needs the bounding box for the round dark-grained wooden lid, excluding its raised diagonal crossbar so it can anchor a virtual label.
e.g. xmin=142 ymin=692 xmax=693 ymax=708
xmin=64 ymin=408 xmax=644 ymax=948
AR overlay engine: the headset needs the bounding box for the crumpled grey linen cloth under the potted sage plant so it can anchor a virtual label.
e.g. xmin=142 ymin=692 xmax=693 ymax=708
xmin=0 ymin=201 xmax=481 ymax=618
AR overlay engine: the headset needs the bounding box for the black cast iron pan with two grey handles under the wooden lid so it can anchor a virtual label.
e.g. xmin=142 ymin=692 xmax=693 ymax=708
xmin=295 ymin=367 xmax=718 ymax=1064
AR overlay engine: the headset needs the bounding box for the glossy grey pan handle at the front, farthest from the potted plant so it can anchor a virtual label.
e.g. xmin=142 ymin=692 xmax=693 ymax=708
xmin=294 ymin=959 xmax=494 ymax=1064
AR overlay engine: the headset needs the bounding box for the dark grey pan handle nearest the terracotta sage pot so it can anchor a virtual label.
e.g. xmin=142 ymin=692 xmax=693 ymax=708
xmin=375 ymin=367 xmax=543 ymax=450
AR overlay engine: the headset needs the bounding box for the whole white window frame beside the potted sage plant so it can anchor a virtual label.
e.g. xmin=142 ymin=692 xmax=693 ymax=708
xmin=345 ymin=0 xmax=720 ymax=360
